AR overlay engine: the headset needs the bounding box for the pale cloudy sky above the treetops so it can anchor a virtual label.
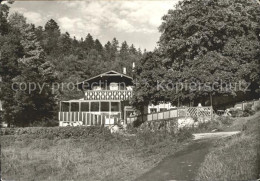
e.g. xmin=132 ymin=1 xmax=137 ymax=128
xmin=7 ymin=0 xmax=179 ymax=51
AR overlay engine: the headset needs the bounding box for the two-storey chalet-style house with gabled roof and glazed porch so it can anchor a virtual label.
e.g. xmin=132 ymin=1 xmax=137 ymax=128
xmin=59 ymin=71 xmax=134 ymax=126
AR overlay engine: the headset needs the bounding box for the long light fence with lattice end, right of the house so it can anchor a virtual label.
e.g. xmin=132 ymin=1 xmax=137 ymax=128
xmin=127 ymin=107 xmax=213 ymax=123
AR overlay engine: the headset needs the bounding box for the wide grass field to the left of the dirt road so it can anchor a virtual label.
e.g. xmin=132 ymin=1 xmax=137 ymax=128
xmin=1 ymin=126 xmax=192 ymax=181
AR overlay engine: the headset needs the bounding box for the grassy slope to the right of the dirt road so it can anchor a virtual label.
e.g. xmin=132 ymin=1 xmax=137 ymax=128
xmin=196 ymin=112 xmax=260 ymax=181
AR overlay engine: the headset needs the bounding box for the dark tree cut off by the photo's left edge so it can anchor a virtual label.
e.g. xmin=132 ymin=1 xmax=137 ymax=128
xmin=0 ymin=4 xmax=24 ymax=126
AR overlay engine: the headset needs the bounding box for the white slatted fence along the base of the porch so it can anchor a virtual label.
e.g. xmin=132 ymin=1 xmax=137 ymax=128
xmin=59 ymin=112 xmax=119 ymax=126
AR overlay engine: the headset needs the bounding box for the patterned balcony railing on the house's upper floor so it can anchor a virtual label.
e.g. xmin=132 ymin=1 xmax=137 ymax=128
xmin=85 ymin=90 xmax=133 ymax=100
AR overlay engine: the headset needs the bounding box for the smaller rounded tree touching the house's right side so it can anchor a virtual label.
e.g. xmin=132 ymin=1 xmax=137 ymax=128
xmin=131 ymin=52 xmax=166 ymax=113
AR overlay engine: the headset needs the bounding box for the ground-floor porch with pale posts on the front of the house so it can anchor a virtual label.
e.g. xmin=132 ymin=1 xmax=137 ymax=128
xmin=59 ymin=100 xmax=122 ymax=126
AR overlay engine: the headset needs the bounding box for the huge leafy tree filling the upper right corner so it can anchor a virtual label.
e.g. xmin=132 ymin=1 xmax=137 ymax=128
xmin=159 ymin=0 xmax=260 ymax=106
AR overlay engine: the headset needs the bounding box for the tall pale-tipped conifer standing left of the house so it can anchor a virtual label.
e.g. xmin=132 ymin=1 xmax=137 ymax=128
xmin=13 ymin=25 xmax=56 ymax=126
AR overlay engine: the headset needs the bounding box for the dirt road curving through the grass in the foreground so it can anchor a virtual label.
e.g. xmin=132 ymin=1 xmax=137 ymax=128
xmin=136 ymin=132 xmax=239 ymax=181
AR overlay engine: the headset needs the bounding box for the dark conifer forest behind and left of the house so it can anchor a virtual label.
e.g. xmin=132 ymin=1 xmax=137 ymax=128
xmin=0 ymin=4 xmax=143 ymax=126
